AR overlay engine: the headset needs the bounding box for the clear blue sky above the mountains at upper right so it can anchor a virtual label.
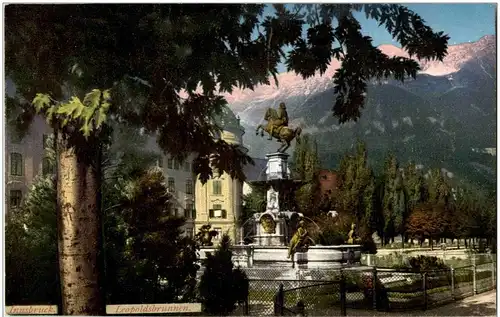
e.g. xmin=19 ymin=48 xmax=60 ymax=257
xmin=266 ymin=3 xmax=497 ymax=72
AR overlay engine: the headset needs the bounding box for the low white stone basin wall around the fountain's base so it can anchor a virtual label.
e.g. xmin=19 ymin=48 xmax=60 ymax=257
xmin=199 ymin=245 xmax=361 ymax=269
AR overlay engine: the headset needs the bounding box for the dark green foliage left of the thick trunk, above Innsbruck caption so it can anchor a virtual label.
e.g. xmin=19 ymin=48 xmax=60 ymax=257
xmin=5 ymin=176 xmax=60 ymax=305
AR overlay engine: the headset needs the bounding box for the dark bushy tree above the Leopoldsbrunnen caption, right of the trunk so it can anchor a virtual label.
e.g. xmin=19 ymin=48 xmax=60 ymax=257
xmin=107 ymin=170 xmax=199 ymax=304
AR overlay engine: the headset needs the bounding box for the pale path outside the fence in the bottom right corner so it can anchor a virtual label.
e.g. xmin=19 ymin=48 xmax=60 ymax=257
xmin=347 ymin=290 xmax=497 ymax=316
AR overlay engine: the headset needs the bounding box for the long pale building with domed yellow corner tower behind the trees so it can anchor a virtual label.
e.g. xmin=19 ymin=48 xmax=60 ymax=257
xmin=5 ymin=103 xmax=250 ymax=242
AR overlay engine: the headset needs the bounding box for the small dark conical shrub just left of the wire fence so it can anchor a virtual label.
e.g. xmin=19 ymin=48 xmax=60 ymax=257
xmin=198 ymin=235 xmax=249 ymax=315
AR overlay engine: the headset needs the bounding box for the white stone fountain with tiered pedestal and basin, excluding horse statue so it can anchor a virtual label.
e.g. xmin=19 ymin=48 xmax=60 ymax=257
xmin=240 ymin=152 xmax=361 ymax=269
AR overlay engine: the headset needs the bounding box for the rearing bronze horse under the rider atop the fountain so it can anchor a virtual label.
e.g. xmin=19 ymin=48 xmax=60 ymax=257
xmin=255 ymin=108 xmax=302 ymax=152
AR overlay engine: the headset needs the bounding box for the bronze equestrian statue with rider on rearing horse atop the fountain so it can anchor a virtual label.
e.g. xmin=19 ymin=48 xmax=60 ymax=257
xmin=255 ymin=102 xmax=302 ymax=152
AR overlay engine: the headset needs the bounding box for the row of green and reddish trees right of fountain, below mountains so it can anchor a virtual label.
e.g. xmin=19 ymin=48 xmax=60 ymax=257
xmin=328 ymin=144 xmax=496 ymax=250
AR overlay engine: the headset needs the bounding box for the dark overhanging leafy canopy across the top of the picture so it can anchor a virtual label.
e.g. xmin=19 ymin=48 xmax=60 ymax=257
xmin=5 ymin=4 xmax=448 ymax=180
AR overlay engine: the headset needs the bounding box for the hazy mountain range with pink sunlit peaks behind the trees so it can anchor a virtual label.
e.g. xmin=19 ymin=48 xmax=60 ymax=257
xmin=225 ymin=35 xmax=497 ymax=188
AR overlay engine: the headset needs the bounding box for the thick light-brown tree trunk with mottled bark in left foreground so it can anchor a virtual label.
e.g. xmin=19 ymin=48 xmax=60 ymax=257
xmin=57 ymin=137 xmax=105 ymax=315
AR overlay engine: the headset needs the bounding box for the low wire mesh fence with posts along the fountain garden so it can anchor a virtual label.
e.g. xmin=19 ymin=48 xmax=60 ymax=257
xmin=241 ymin=262 xmax=496 ymax=316
